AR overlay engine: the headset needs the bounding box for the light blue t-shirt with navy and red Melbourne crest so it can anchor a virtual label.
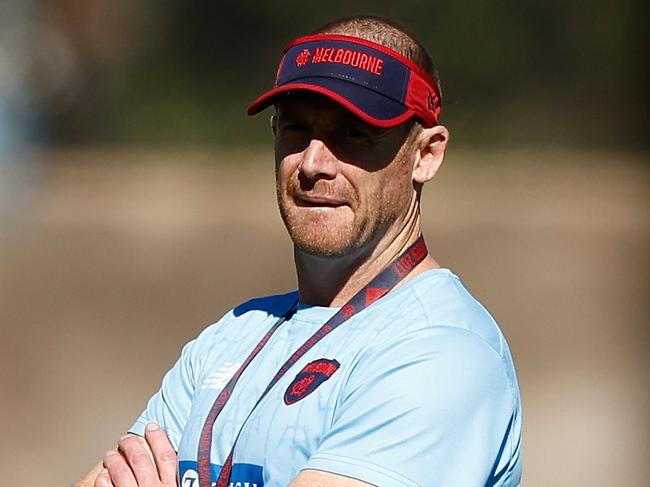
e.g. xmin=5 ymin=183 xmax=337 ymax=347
xmin=131 ymin=269 xmax=521 ymax=487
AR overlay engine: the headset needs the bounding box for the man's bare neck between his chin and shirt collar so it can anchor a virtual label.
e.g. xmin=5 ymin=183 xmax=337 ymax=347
xmin=294 ymin=216 xmax=439 ymax=307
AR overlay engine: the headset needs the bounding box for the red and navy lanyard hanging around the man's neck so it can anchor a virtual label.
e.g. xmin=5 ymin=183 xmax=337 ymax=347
xmin=197 ymin=236 xmax=428 ymax=487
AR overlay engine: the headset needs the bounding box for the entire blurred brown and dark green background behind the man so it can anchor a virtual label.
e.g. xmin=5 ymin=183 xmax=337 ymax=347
xmin=0 ymin=0 xmax=650 ymax=487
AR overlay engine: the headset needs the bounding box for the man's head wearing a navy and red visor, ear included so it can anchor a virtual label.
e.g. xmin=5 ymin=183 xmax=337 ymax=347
xmin=249 ymin=17 xmax=448 ymax=257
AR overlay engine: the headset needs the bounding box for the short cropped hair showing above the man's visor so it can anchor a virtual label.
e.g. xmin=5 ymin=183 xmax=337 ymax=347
xmin=312 ymin=15 xmax=440 ymax=92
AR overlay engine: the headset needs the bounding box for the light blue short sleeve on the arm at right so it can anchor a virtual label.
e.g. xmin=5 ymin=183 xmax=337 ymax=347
xmin=304 ymin=326 xmax=518 ymax=487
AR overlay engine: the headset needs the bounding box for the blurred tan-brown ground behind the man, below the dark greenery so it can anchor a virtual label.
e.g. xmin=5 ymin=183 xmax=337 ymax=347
xmin=0 ymin=150 xmax=650 ymax=487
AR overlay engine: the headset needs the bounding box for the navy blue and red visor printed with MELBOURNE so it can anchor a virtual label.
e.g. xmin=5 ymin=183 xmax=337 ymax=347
xmin=248 ymin=34 xmax=440 ymax=127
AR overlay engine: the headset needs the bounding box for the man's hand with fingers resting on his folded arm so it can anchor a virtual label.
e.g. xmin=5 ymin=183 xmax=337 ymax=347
xmin=95 ymin=423 xmax=178 ymax=487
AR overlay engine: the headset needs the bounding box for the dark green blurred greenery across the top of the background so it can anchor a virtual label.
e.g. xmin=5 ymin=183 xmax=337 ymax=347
xmin=45 ymin=0 xmax=650 ymax=149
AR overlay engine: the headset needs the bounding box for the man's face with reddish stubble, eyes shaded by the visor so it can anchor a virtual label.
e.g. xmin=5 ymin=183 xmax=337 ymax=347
xmin=274 ymin=92 xmax=416 ymax=257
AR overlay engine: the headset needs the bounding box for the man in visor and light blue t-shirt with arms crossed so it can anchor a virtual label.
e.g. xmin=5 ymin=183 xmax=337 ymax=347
xmin=81 ymin=17 xmax=521 ymax=487
